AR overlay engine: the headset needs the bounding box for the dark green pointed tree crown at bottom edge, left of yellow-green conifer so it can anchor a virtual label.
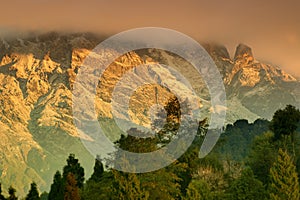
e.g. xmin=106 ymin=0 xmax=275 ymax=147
xmin=228 ymin=168 xmax=267 ymax=200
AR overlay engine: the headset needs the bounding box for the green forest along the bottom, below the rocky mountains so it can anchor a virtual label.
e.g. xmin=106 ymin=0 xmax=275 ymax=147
xmin=0 ymin=105 xmax=300 ymax=200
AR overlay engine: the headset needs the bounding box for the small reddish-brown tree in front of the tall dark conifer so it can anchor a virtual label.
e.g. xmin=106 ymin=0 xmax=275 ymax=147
xmin=64 ymin=173 xmax=80 ymax=200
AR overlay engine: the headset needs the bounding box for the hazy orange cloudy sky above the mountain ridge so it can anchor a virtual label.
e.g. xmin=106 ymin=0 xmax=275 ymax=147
xmin=0 ymin=0 xmax=300 ymax=77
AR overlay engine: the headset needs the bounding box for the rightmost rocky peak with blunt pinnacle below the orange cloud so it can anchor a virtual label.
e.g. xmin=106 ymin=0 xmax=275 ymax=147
xmin=225 ymin=45 xmax=299 ymax=119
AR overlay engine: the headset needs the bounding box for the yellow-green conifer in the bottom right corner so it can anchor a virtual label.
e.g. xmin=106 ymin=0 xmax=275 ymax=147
xmin=270 ymin=149 xmax=300 ymax=200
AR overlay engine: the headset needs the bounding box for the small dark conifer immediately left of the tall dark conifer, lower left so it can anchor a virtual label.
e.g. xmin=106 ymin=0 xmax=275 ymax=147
xmin=48 ymin=171 xmax=64 ymax=200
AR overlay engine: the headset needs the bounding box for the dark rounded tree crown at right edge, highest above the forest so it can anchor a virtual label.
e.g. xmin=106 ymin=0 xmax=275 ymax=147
xmin=270 ymin=105 xmax=300 ymax=139
